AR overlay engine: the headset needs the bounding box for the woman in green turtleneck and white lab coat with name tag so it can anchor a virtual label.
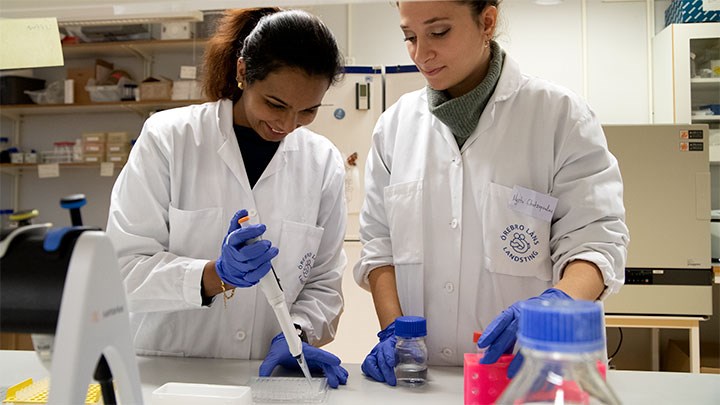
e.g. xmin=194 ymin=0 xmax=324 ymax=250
xmin=355 ymin=0 xmax=628 ymax=385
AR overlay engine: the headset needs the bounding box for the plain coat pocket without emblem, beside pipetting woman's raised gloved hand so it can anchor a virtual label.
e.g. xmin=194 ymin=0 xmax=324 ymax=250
xmin=168 ymin=206 xmax=222 ymax=260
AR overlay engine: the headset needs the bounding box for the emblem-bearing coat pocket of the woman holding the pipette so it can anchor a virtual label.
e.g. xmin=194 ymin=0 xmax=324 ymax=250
xmin=273 ymin=220 xmax=325 ymax=303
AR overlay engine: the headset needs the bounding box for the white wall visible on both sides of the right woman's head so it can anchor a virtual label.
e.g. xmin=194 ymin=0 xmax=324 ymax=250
xmin=342 ymin=0 xmax=666 ymax=124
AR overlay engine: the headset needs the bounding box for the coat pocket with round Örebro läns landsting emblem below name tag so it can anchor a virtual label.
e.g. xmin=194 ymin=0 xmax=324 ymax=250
xmin=481 ymin=183 xmax=552 ymax=281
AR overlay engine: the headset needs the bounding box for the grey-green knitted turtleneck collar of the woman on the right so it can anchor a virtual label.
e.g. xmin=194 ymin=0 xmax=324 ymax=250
xmin=427 ymin=41 xmax=505 ymax=148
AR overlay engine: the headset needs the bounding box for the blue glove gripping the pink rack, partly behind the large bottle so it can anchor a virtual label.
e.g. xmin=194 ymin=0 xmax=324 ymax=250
xmin=478 ymin=288 xmax=572 ymax=378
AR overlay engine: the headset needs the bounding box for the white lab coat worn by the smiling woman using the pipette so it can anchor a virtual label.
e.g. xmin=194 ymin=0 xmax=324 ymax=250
xmin=107 ymin=100 xmax=347 ymax=359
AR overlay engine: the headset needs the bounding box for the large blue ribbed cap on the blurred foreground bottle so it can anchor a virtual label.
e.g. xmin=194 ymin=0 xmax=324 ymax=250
xmin=518 ymin=300 xmax=605 ymax=353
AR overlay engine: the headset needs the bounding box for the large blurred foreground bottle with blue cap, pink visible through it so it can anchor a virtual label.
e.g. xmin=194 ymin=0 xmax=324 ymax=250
xmin=497 ymin=301 xmax=620 ymax=404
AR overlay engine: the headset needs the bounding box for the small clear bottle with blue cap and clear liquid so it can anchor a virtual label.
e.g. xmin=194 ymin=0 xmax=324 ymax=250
xmin=395 ymin=316 xmax=427 ymax=387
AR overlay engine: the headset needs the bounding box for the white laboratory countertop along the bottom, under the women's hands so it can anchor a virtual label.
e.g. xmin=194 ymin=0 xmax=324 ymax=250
xmin=0 ymin=350 xmax=720 ymax=405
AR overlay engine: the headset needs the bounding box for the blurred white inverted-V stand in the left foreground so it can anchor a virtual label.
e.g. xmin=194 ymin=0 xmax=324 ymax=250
xmin=48 ymin=231 xmax=143 ymax=404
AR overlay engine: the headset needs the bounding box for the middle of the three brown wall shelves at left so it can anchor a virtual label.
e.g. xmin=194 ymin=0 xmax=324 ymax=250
xmin=0 ymin=100 xmax=205 ymax=119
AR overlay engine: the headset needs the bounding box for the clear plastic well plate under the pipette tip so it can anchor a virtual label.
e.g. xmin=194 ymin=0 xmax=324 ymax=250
xmin=250 ymin=377 xmax=328 ymax=404
